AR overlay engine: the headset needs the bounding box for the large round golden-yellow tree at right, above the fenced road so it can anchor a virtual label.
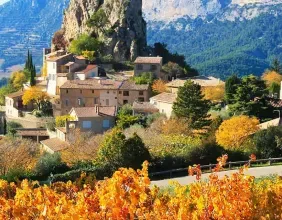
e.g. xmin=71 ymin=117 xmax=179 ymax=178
xmin=216 ymin=115 xmax=259 ymax=150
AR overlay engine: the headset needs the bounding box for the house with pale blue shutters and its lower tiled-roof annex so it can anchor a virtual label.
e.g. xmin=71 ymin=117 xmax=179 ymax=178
xmin=41 ymin=106 xmax=117 ymax=153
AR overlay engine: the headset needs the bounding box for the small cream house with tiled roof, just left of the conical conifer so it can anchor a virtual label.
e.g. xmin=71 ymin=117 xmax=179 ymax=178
xmin=150 ymin=92 xmax=177 ymax=118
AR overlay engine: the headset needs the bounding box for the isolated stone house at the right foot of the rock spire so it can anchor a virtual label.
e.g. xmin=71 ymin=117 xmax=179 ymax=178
xmin=134 ymin=57 xmax=163 ymax=78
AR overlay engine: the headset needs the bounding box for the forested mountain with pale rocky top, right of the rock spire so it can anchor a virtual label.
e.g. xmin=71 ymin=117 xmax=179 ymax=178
xmin=143 ymin=0 xmax=282 ymax=78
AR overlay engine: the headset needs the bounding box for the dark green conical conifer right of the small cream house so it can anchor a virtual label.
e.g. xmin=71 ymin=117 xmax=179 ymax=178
xmin=173 ymin=80 xmax=210 ymax=129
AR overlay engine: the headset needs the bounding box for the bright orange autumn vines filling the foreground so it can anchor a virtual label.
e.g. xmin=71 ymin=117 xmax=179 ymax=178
xmin=0 ymin=155 xmax=282 ymax=220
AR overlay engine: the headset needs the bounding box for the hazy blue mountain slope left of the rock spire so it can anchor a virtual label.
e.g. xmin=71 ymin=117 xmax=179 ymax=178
xmin=0 ymin=0 xmax=69 ymax=77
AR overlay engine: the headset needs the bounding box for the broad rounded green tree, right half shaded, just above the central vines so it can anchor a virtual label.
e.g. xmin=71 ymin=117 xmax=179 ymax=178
xmin=96 ymin=129 xmax=150 ymax=171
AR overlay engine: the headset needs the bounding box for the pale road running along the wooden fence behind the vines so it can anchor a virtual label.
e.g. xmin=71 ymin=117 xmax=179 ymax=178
xmin=151 ymin=166 xmax=282 ymax=187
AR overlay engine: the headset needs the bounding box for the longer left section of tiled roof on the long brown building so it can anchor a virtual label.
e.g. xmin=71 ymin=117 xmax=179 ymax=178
xmin=61 ymin=79 xmax=122 ymax=90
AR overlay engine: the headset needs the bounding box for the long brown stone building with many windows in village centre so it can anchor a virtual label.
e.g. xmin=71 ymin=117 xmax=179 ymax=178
xmin=60 ymin=79 xmax=150 ymax=115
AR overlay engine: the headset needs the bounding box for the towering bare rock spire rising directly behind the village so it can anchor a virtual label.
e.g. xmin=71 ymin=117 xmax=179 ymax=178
xmin=56 ymin=0 xmax=146 ymax=61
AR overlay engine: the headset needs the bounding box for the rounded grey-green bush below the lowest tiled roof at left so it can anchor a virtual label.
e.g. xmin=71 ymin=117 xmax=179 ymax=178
xmin=35 ymin=153 xmax=69 ymax=177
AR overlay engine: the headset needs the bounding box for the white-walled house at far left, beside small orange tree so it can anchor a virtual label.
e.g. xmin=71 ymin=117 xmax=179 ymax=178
xmin=5 ymin=90 xmax=34 ymax=118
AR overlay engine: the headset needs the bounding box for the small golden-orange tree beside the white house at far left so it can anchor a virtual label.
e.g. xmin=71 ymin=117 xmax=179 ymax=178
xmin=23 ymin=87 xmax=50 ymax=110
